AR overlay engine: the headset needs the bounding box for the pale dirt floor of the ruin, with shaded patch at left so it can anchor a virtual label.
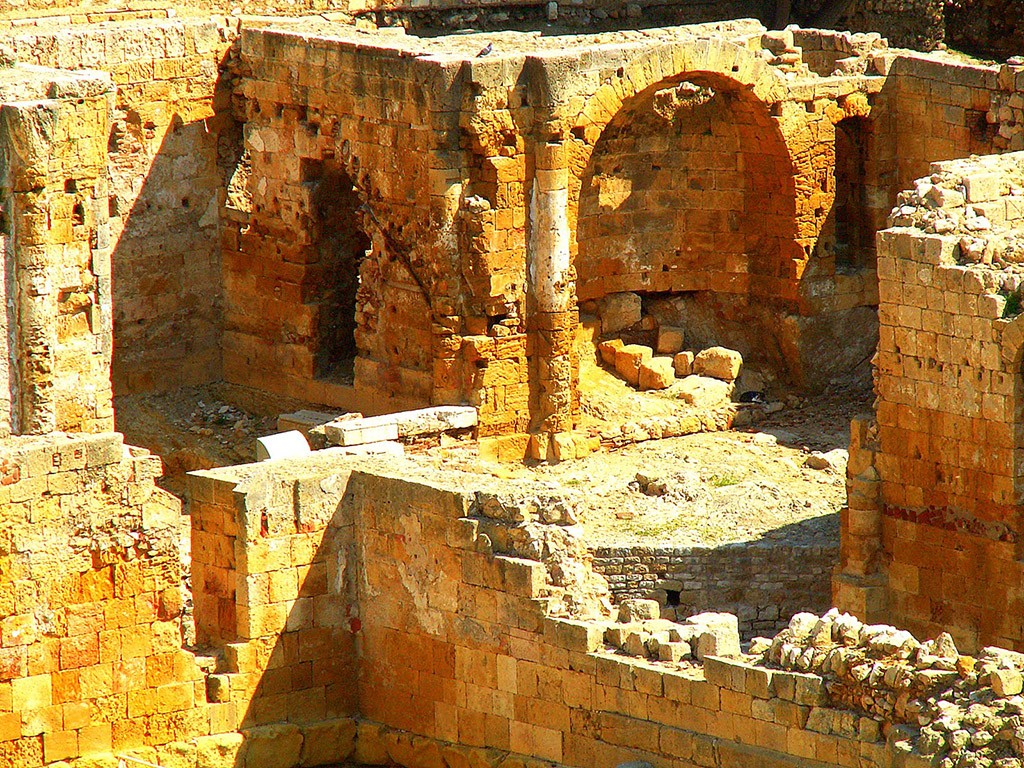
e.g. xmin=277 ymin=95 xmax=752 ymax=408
xmin=116 ymin=382 xmax=870 ymax=546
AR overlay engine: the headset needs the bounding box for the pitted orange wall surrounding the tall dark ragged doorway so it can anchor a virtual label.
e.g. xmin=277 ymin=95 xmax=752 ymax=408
xmin=224 ymin=30 xmax=454 ymax=411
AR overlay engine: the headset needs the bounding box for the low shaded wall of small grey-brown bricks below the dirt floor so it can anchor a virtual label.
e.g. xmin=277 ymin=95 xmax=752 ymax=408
xmin=594 ymin=542 xmax=839 ymax=639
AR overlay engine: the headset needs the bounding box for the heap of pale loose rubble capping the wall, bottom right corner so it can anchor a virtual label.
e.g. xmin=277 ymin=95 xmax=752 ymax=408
xmin=751 ymin=608 xmax=1024 ymax=768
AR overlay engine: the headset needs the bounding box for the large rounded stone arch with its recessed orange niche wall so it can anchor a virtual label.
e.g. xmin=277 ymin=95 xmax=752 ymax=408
xmin=567 ymin=40 xmax=809 ymax=382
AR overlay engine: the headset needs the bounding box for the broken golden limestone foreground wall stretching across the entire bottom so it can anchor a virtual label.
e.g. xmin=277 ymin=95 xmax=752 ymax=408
xmin=0 ymin=434 xmax=1020 ymax=768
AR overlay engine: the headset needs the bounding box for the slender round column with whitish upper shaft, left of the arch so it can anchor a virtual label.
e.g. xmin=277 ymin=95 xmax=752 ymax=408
xmin=527 ymin=142 xmax=575 ymax=432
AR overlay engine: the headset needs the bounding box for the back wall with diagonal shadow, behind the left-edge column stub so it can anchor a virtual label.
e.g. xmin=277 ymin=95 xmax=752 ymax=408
xmin=0 ymin=14 xmax=238 ymax=394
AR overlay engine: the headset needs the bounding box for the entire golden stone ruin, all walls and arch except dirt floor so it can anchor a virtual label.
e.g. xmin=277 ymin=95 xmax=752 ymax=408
xmin=0 ymin=3 xmax=1024 ymax=768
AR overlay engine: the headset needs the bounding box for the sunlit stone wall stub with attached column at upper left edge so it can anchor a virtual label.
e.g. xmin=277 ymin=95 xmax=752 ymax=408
xmin=0 ymin=67 xmax=114 ymax=434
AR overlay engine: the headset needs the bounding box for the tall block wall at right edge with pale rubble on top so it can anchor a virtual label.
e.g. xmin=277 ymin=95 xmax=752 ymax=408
xmin=836 ymin=153 xmax=1024 ymax=649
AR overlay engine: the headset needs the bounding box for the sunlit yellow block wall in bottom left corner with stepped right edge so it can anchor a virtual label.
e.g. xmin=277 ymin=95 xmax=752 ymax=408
xmin=0 ymin=433 xmax=209 ymax=768
